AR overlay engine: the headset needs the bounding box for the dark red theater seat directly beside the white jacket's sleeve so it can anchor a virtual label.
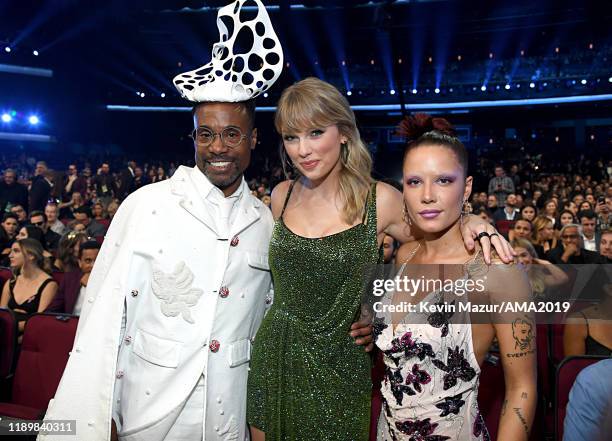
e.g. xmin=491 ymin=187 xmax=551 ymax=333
xmin=0 ymin=314 xmax=78 ymax=420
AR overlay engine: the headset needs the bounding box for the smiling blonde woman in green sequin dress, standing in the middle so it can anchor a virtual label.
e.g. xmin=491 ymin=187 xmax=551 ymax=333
xmin=247 ymin=78 xmax=510 ymax=441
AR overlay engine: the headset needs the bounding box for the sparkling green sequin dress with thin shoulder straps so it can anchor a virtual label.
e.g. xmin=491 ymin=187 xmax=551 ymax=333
xmin=247 ymin=183 xmax=380 ymax=441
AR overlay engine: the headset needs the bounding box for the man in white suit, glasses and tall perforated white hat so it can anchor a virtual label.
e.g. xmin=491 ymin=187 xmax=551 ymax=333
xmin=39 ymin=0 xmax=378 ymax=441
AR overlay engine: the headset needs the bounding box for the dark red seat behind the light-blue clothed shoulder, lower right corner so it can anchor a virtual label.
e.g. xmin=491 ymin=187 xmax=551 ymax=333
xmin=554 ymin=355 xmax=607 ymax=440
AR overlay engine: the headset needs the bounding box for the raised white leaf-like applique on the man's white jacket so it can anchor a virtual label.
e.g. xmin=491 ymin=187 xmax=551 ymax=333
xmin=152 ymin=262 xmax=204 ymax=324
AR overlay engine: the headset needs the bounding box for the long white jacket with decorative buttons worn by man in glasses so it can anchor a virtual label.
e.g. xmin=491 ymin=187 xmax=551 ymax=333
xmin=38 ymin=167 xmax=274 ymax=441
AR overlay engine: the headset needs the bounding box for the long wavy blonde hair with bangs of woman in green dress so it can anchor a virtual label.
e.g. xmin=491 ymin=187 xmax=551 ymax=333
xmin=274 ymin=77 xmax=374 ymax=224
